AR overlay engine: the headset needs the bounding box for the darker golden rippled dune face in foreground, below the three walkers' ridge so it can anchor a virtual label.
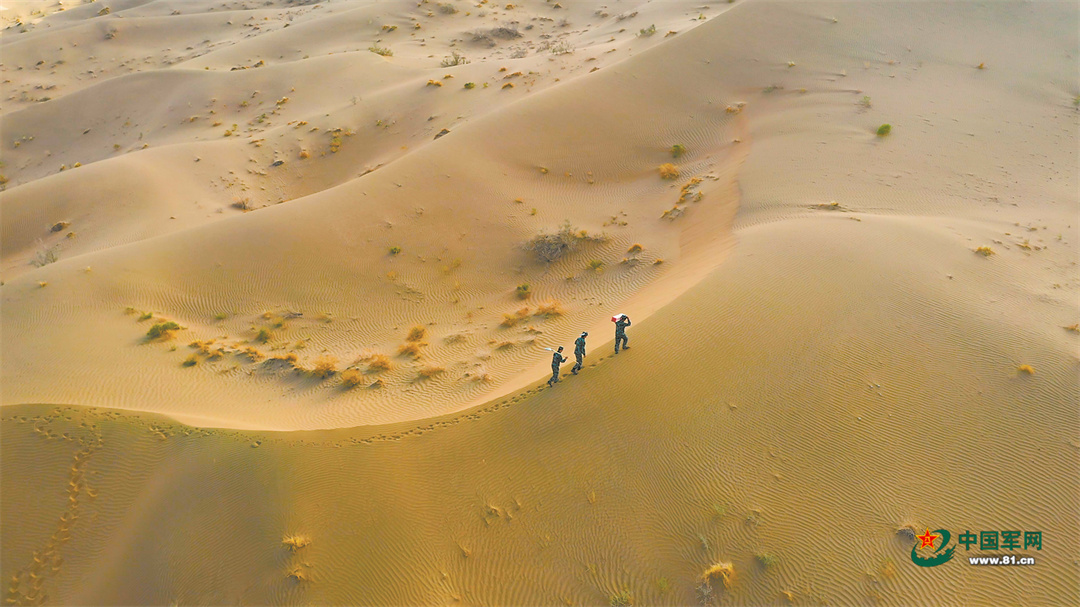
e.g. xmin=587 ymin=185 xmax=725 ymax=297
xmin=2 ymin=219 xmax=1080 ymax=605
